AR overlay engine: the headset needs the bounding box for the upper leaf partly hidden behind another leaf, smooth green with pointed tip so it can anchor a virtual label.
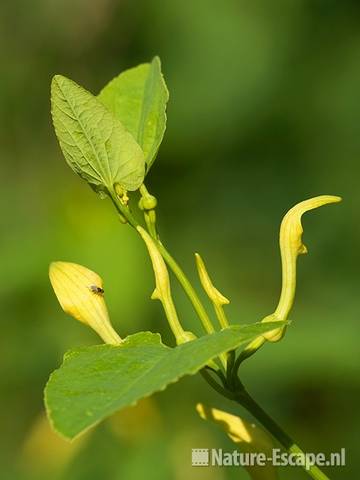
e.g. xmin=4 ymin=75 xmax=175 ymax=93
xmin=98 ymin=57 xmax=169 ymax=169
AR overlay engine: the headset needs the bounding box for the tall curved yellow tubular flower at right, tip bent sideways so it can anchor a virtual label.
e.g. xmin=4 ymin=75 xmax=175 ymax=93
xmin=262 ymin=195 xmax=341 ymax=342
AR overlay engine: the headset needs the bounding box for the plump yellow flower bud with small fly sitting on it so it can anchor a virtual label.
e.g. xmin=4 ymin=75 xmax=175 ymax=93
xmin=49 ymin=262 xmax=122 ymax=345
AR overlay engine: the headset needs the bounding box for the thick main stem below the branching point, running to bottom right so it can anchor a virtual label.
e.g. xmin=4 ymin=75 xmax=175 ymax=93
xmin=234 ymin=389 xmax=329 ymax=480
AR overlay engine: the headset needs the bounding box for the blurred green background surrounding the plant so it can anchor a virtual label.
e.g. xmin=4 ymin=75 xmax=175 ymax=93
xmin=0 ymin=0 xmax=360 ymax=480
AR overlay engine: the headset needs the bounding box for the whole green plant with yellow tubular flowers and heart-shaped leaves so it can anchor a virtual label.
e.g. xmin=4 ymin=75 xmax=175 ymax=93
xmin=45 ymin=58 xmax=341 ymax=479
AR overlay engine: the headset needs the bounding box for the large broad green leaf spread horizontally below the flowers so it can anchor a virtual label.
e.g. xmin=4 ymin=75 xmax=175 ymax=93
xmin=45 ymin=323 xmax=279 ymax=438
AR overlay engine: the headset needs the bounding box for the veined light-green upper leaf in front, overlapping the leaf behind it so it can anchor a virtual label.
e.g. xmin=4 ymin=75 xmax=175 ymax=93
xmin=51 ymin=75 xmax=145 ymax=193
